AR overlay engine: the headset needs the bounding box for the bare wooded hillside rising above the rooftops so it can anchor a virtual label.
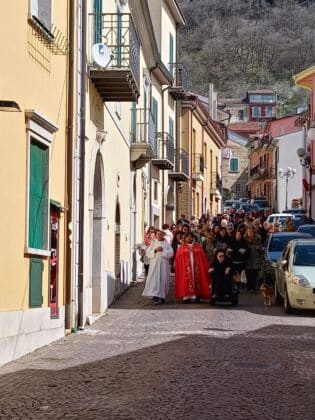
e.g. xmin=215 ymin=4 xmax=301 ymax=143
xmin=178 ymin=0 xmax=315 ymax=112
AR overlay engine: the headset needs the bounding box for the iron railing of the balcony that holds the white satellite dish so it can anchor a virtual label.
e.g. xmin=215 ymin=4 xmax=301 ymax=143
xmin=89 ymin=13 xmax=140 ymax=86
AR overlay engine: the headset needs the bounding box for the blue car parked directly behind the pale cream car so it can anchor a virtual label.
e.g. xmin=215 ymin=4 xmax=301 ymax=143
xmin=262 ymin=232 xmax=311 ymax=283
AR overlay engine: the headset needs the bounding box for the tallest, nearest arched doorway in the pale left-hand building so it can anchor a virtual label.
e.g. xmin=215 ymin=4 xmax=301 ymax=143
xmin=92 ymin=154 xmax=103 ymax=313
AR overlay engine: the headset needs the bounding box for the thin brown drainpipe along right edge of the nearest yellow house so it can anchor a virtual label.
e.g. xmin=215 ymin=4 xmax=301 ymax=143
xmin=65 ymin=1 xmax=75 ymax=330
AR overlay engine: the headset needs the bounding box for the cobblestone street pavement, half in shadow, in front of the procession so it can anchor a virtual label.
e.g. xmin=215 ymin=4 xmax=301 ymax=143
xmin=0 ymin=283 xmax=315 ymax=420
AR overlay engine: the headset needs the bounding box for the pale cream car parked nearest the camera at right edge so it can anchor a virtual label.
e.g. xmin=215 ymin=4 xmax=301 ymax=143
xmin=275 ymin=239 xmax=315 ymax=313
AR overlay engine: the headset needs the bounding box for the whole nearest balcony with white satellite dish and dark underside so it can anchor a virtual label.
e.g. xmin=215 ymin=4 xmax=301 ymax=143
xmin=88 ymin=13 xmax=140 ymax=102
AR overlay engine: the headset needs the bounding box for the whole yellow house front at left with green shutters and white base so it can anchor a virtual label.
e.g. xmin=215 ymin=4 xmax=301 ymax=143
xmin=0 ymin=1 xmax=68 ymax=364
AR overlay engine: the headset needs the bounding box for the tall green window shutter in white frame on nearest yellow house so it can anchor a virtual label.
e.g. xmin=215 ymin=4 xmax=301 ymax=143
xmin=28 ymin=139 xmax=49 ymax=249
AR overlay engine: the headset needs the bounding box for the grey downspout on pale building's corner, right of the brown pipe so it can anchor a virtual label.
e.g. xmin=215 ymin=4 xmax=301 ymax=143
xmin=78 ymin=0 xmax=87 ymax=329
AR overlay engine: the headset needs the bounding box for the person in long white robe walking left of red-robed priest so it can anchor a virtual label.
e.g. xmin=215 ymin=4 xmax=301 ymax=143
xmin=142 ymin=230 xmax=174 ymax=305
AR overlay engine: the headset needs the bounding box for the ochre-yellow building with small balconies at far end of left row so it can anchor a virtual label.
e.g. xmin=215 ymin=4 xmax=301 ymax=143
xmin=177 ymin=94 xmax=226 ymax=219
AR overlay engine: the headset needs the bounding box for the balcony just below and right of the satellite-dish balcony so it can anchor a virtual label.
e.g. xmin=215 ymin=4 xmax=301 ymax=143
xmin=130 ymin=108 xmax=157 ymax=169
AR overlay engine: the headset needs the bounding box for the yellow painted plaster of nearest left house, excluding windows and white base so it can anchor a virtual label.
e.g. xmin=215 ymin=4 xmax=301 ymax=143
xmin=0 ymin=0 xmax=68 ymax=311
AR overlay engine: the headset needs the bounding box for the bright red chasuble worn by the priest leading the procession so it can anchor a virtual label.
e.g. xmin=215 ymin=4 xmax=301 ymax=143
xmin=175 ymin=243 xmax=210 ymax=299
